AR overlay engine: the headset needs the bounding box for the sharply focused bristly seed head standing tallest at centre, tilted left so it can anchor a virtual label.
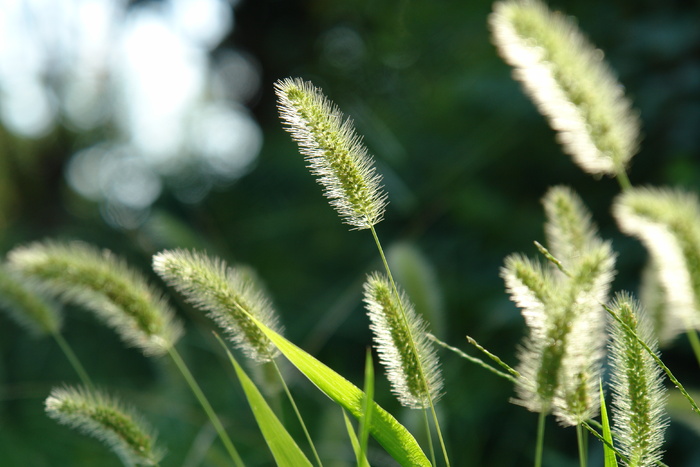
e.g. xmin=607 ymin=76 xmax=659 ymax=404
xmin=275 ymin=78 xmax=387 ymax=229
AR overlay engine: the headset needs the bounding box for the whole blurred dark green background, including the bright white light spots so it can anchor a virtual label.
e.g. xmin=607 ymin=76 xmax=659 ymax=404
xmin=0 ymin=0 xmax=700 ymax=467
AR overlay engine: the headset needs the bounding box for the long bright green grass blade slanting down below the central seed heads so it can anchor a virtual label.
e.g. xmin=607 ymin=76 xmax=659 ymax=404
xmin=246 ymin=316 xmax=430 ymax=467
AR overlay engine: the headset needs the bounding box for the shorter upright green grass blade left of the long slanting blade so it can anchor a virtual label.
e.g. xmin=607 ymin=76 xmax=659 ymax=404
xmin=217 ymin=336 xmax=312 ymax=467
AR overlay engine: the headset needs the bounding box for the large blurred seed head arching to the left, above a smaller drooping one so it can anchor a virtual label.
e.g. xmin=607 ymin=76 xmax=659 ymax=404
xmin=8 ymin=241 xmax=182 ymax=355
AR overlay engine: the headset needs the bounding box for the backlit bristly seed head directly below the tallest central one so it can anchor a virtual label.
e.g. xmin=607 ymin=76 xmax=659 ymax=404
xmin=364 ymin=273 xmax=443 ymax=409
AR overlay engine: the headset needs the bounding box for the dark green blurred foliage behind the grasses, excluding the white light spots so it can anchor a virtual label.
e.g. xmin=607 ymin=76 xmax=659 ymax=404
xmin=0 ymin=0 xmax=700 ymax=467
